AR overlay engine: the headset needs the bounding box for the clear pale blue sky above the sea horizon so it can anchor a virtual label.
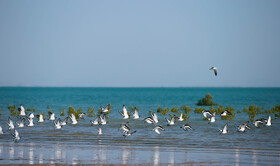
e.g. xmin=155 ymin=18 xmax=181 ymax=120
xmin=0 ymin=0 xmax=280 ymax=87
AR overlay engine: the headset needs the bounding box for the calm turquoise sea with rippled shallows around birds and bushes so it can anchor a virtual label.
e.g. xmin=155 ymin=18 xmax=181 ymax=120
xmin=0 ymin=87 xmax=280 ymax=165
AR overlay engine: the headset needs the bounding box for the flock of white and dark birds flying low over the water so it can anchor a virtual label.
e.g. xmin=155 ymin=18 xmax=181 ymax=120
xmin=0 ymin=102 xmax=271 ymax=142
